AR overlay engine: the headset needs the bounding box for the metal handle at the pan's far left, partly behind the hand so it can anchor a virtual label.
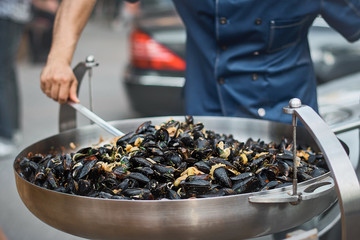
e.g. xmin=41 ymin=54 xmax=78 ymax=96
xmin=59 ymin=55 xmax=99 ymax=132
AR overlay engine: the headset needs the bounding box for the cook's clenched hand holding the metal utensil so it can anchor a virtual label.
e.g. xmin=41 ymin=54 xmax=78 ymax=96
xmin=40 ymin=61 xmax=79 ymax=104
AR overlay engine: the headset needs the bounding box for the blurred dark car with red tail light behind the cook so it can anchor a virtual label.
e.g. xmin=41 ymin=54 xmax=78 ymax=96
xmin=124 ymin=0 xmax=186 ymax=116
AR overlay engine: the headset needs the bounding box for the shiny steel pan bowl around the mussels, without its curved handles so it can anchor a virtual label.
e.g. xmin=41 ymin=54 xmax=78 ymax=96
xmin=14 ymin=117 xmax=336 ymax=240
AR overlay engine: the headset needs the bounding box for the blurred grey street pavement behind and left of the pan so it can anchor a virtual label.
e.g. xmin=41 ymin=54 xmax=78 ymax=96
xmin=0 ymin=21 xmax=137 ymax=240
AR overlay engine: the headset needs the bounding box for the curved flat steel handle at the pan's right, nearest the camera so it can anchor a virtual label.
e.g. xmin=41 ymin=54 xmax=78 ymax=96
xmin=284 ymin=99 xmax=360 ymax=240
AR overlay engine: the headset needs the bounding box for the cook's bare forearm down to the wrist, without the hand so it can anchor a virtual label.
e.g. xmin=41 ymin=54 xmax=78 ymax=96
xmin=48 ymin=0 xmax=96 ymax=65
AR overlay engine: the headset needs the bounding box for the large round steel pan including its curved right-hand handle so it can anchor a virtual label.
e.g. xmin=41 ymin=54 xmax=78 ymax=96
xmin=14 ymin=57 xmax=360 ymax=240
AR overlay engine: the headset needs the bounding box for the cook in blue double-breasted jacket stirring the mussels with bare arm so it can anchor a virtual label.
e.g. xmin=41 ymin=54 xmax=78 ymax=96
xmin=41 ymin=0 xmax=360 ymax=122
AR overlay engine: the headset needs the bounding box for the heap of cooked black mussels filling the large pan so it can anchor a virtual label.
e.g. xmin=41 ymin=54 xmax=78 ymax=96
xmin=18 ymin=116 xmax=328 ymax=200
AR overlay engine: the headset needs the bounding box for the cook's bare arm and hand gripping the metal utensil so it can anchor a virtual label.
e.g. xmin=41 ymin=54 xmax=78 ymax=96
xmin=40 ymin=0 xmax=96 ymax=104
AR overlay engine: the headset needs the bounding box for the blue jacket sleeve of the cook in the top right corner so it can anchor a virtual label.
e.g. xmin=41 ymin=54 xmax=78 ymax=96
xmin=321 ymin=0 xmax=360 ymax=42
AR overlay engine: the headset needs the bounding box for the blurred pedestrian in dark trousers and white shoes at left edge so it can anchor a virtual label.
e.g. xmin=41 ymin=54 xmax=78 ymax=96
xmin=0 ymin=0 xmax=31 ymax=158
